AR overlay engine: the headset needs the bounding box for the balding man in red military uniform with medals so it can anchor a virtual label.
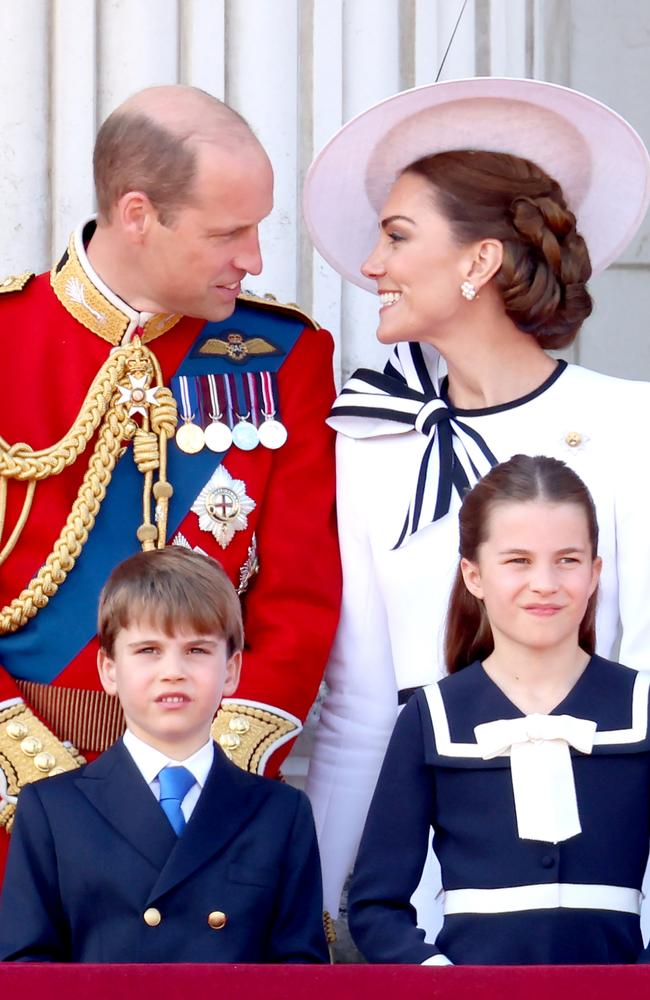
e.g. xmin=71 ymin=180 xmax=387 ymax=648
xmin=0 ymin=87 xmax=340 ymax=880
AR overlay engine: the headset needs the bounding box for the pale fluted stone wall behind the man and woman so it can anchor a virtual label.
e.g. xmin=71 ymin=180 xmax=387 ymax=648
xmin=0 ymin=0 xmax=650 ymax=378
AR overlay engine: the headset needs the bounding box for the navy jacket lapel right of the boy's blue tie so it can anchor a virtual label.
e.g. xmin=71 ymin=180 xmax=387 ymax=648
xmin=147 ymin=744 xmax=270 ymax=906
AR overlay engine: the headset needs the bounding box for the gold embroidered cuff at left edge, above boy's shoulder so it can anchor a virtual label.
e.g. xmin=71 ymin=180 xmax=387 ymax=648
xmin=0 ymin=702 xmax=86 ymax=833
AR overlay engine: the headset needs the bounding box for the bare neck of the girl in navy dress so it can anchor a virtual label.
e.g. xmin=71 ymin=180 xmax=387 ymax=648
xmin=483 ymin=637 xmax=590 ymax=715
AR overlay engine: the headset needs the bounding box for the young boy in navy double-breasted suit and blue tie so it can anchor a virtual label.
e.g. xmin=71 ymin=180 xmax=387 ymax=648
xmin=0 ymin=548 xmax=327 ymax=962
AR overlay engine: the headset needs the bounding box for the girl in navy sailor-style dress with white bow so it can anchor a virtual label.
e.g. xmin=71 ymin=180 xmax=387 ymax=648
xmin=350 ymin=455 xmax=650 ymax=965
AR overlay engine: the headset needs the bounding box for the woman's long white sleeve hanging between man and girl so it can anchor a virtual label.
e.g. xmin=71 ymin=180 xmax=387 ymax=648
xmin=307 ymin=435 xmax=397 ymax=916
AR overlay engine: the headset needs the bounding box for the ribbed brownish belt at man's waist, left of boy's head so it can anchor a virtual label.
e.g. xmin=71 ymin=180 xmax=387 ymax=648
xmin=16 ymin=680 xmax=125 ymax=753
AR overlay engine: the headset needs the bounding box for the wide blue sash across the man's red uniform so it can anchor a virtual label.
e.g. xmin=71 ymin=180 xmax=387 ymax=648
xmin=0 ymin=301 xmax=305 ymax=683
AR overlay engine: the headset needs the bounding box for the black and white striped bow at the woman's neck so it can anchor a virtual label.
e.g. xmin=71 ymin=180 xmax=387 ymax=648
xmin=327 ymin=343 xmax=497 ymax=549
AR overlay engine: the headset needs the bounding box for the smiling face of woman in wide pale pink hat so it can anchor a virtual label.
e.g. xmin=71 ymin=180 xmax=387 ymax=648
xmin=361 ymin=174 xmax=474 ymax=344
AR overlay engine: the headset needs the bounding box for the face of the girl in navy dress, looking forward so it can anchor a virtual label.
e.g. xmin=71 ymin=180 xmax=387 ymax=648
xmin=461 ymin=500 xmax=601 ymax=651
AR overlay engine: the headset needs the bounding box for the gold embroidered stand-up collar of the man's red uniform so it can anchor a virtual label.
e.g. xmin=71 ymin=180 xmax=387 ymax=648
xmin=50 ymin=222 xmax=182 ymax=347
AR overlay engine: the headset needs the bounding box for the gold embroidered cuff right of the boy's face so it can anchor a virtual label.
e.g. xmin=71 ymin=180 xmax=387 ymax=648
xmin=211 ymin=702 xmax=299 ymax=774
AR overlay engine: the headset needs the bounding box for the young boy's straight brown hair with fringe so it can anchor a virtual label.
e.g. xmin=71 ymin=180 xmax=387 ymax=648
xmin=97 ymin=546 xmax=244 ymax=657
